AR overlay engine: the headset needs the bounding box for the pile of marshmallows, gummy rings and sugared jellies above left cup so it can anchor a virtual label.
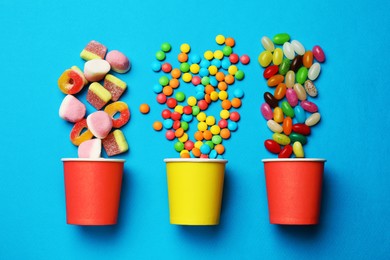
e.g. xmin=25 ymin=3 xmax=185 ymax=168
xmin=58 ymin=41 xmax=131 ymax=158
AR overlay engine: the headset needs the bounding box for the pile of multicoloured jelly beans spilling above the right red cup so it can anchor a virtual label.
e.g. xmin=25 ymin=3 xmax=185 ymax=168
xmin=258 ymin=33 xmax=325 ymax=158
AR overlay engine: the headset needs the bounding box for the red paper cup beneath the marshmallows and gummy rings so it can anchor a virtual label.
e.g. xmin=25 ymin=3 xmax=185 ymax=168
xmin=62 ymin=158 xmax=125 ymax=225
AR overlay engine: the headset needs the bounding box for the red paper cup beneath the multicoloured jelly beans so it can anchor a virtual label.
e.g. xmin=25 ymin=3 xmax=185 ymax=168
xmin=263 ymin=158 xmax=326 ymax=225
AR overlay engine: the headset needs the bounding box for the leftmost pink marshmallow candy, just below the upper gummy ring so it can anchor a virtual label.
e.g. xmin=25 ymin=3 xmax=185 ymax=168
xmin=59 ymin=95 xmax=86 ymax=123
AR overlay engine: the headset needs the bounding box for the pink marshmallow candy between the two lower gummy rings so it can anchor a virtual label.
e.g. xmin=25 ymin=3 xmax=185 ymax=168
xmin=87 ymin=111 xmax=112 ymax=139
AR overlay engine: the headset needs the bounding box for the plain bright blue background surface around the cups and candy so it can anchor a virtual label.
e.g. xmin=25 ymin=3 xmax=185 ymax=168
xmin=0 ymin=0 xmax=390 ymax=259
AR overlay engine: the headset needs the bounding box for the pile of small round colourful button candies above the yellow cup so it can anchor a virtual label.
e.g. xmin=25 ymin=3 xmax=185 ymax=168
xmin=152 ymin=35 xmax=250 ymax=158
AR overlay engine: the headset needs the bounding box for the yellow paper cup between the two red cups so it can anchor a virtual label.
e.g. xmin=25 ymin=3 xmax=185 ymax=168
xmin=164 ymin=158 xmax=227 ymax=225
